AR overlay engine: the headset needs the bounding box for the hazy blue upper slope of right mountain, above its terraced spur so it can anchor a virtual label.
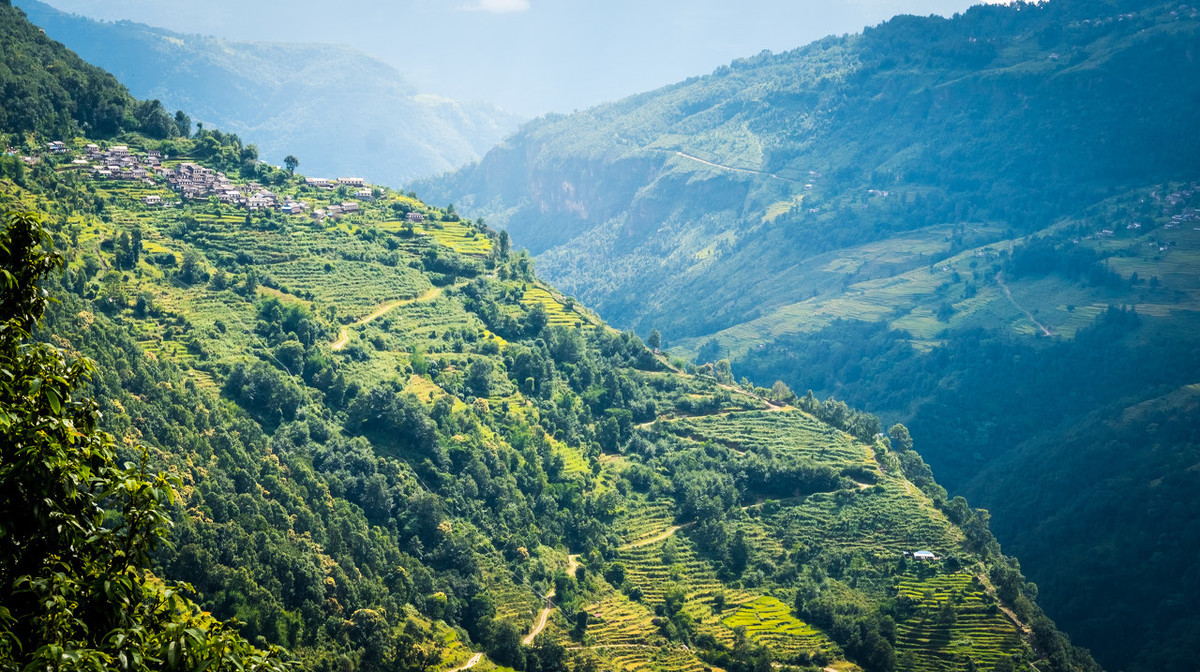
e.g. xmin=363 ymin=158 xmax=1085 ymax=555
xmin=415 ymin=2 xmax=1198 ymax=340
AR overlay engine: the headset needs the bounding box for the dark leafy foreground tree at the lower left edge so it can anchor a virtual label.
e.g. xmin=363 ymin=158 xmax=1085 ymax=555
xmin=0 ymin=214 xmax=288 ymax=672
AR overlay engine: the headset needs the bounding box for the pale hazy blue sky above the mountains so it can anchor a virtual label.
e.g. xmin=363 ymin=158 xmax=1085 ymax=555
xmin=44 ymin=0 xmax=993 ymax=116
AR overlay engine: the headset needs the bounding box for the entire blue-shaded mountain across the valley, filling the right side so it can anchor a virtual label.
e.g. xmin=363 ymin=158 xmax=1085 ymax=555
xmin=412 ymin=0 xmax=1200 ymax=670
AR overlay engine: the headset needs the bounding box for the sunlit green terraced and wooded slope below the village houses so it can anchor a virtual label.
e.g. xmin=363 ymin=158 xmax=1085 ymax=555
xmin=9 ymin=137 xmax=1091 ymax=670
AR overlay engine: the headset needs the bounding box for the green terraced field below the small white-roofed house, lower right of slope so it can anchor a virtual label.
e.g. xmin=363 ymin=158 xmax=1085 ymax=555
xmin=896 ymin=572 xmax=1021 ymax=672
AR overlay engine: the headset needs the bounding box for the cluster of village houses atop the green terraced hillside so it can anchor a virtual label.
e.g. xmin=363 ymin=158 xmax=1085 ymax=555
xmin=46 ymin=142 xmax=374 ymax=220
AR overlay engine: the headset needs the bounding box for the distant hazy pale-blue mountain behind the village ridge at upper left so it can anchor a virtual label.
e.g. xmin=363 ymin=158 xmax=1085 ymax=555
xmin=19 ymin=0 xmax=520 ymax=185
